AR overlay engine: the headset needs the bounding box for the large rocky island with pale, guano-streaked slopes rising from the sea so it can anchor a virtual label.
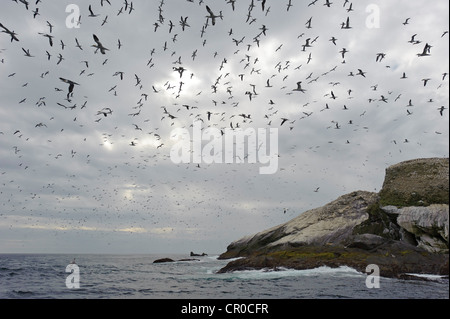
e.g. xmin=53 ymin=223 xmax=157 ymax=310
xmin=219 ymin=158 xmax=449 ymax=278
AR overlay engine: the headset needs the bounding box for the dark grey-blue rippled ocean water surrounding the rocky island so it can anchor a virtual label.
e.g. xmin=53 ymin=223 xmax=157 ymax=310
xmin=0 ymin=254 xmax=449 ymax=300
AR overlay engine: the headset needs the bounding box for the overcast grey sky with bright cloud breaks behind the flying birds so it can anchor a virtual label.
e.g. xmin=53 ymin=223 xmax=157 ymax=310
xmin=0 ymin=0 xmax=449 ymax=253
